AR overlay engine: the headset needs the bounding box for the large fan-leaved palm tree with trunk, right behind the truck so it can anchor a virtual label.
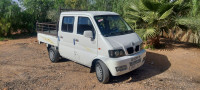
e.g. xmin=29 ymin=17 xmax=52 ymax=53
xmin=125 ymin=0 xmax=182 ymax=46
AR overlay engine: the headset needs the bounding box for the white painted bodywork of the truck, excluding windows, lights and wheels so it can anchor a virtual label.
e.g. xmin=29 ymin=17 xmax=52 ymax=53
xmin=38 ymin=11 xmax=146 ymax=76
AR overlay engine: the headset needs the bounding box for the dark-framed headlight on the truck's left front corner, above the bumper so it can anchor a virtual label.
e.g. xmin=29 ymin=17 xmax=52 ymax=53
xmin=108 ymin=49 xmax=125 ymax=58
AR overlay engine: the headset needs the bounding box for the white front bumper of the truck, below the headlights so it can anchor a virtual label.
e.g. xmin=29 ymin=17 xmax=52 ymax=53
xmin=106 ymin=50 xmax=146 ymax=76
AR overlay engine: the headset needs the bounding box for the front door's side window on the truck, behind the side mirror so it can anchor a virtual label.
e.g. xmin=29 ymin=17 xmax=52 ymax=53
xmin=77 ymin=17 xmax=95 ymax=38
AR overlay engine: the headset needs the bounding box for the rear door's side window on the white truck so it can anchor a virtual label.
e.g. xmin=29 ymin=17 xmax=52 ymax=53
xmin=62 ymin=17 xmax=74 ymax=33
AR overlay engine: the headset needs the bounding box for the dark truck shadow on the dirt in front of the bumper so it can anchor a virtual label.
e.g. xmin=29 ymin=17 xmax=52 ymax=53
xmin=111 ymin=52 xmax=171 ymax=83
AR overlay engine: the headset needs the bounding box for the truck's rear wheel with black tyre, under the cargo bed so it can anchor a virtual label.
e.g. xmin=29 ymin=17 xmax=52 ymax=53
xmin=48 ymin=47 xmax=60 ymax=63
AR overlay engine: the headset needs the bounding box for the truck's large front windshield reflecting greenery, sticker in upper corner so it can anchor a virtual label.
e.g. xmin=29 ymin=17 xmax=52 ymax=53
xmin=94 ymin=15 xmax=134 ymax=37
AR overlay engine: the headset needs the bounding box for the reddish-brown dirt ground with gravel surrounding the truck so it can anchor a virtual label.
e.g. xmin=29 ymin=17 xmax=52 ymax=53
xmin=0 ymin=37 xmax=200 ymax=90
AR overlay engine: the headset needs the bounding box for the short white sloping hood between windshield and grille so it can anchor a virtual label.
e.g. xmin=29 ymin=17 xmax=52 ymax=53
xmin=106 ymin=33 xmax=142 ymax=49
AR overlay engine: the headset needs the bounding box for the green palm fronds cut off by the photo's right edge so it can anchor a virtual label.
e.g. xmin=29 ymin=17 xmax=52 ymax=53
xmin=176 ymin=0 xmax=200 ymax=44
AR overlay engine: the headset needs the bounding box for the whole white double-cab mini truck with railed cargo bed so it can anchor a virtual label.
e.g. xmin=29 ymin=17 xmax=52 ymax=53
xmin=37 ymin=11 xmax=146 ymax=83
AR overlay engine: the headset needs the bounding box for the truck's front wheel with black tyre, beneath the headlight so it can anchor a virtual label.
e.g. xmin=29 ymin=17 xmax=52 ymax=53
xmin=95 ymin=60 xmax=110 ymax=84
